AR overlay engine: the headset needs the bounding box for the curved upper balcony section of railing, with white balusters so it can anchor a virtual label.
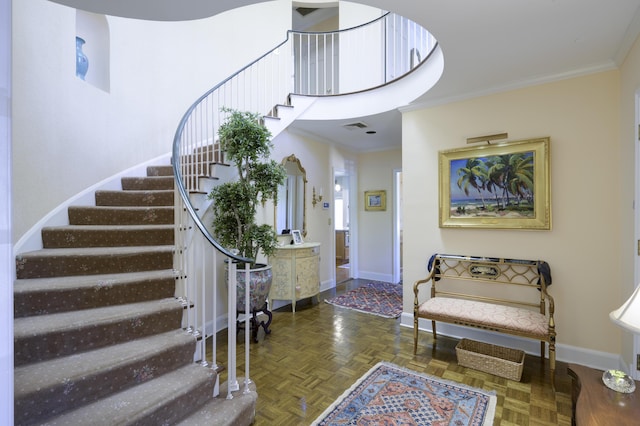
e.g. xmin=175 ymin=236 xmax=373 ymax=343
xmin=289 ymin=13 xmax=436 ymax=96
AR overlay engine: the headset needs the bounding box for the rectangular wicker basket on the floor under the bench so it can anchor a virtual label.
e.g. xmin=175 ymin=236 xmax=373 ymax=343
xmin=456 ymin=339 xmax=524 ymax=381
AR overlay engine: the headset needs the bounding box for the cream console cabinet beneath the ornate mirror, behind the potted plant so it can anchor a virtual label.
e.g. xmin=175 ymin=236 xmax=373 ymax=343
xmin=269 ymin=243 xmax=320 ymax=313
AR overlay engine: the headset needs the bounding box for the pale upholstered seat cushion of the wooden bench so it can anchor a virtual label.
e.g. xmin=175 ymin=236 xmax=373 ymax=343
xmin=418 ymin=297 xmax=549 ymax=340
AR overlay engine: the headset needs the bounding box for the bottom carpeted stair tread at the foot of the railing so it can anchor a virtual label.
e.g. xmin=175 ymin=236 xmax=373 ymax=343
xmin=177 ymin=378 xmax=258 ymax=426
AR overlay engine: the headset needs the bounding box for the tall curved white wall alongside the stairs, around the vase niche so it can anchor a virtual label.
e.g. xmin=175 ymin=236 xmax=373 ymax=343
xmin=11 ymin=0 xmax=291 ymax=244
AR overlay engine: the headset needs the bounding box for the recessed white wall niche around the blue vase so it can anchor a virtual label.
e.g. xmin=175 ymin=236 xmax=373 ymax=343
xmin=72 ymin=10 xmax=111 ymax=92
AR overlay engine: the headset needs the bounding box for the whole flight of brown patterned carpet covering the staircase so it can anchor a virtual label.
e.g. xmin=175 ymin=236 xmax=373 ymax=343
xmin=14 ymin=166 xmax=257 ymax=425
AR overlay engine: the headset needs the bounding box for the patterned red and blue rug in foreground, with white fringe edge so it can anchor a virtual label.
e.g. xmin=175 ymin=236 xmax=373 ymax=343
xmin=312 ymin=362 xmax=497 ymax=426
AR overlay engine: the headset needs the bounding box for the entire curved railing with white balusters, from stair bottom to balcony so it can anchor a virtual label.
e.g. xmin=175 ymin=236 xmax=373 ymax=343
xmin=172 ymin=13 xmax=437 ymax=396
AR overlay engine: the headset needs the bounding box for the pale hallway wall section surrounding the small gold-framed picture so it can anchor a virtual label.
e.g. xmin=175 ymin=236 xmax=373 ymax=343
xmin=357 ymin=149 xmax=403 ymax=282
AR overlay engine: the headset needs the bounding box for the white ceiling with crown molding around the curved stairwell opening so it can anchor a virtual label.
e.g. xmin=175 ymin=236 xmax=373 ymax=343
xmin=52 ymin=0 xmax=640 ymax=151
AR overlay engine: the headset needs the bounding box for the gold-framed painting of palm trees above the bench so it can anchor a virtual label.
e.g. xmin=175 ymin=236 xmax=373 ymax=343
xmin=438 ymin=137 xmax=551 ymax=230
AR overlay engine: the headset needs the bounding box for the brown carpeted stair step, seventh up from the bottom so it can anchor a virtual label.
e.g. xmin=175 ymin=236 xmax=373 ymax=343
xmin=42 ymin=225 xmax=174 ymax=248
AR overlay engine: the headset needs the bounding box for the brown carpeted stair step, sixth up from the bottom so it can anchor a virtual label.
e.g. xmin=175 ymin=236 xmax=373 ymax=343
xmin=16 ymin=246 xmax=174 ymax=279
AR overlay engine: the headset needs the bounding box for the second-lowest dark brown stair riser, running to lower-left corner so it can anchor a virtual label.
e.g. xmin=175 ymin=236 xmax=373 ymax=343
xmin=14 ymin=341 xmax=195 ymax=424
